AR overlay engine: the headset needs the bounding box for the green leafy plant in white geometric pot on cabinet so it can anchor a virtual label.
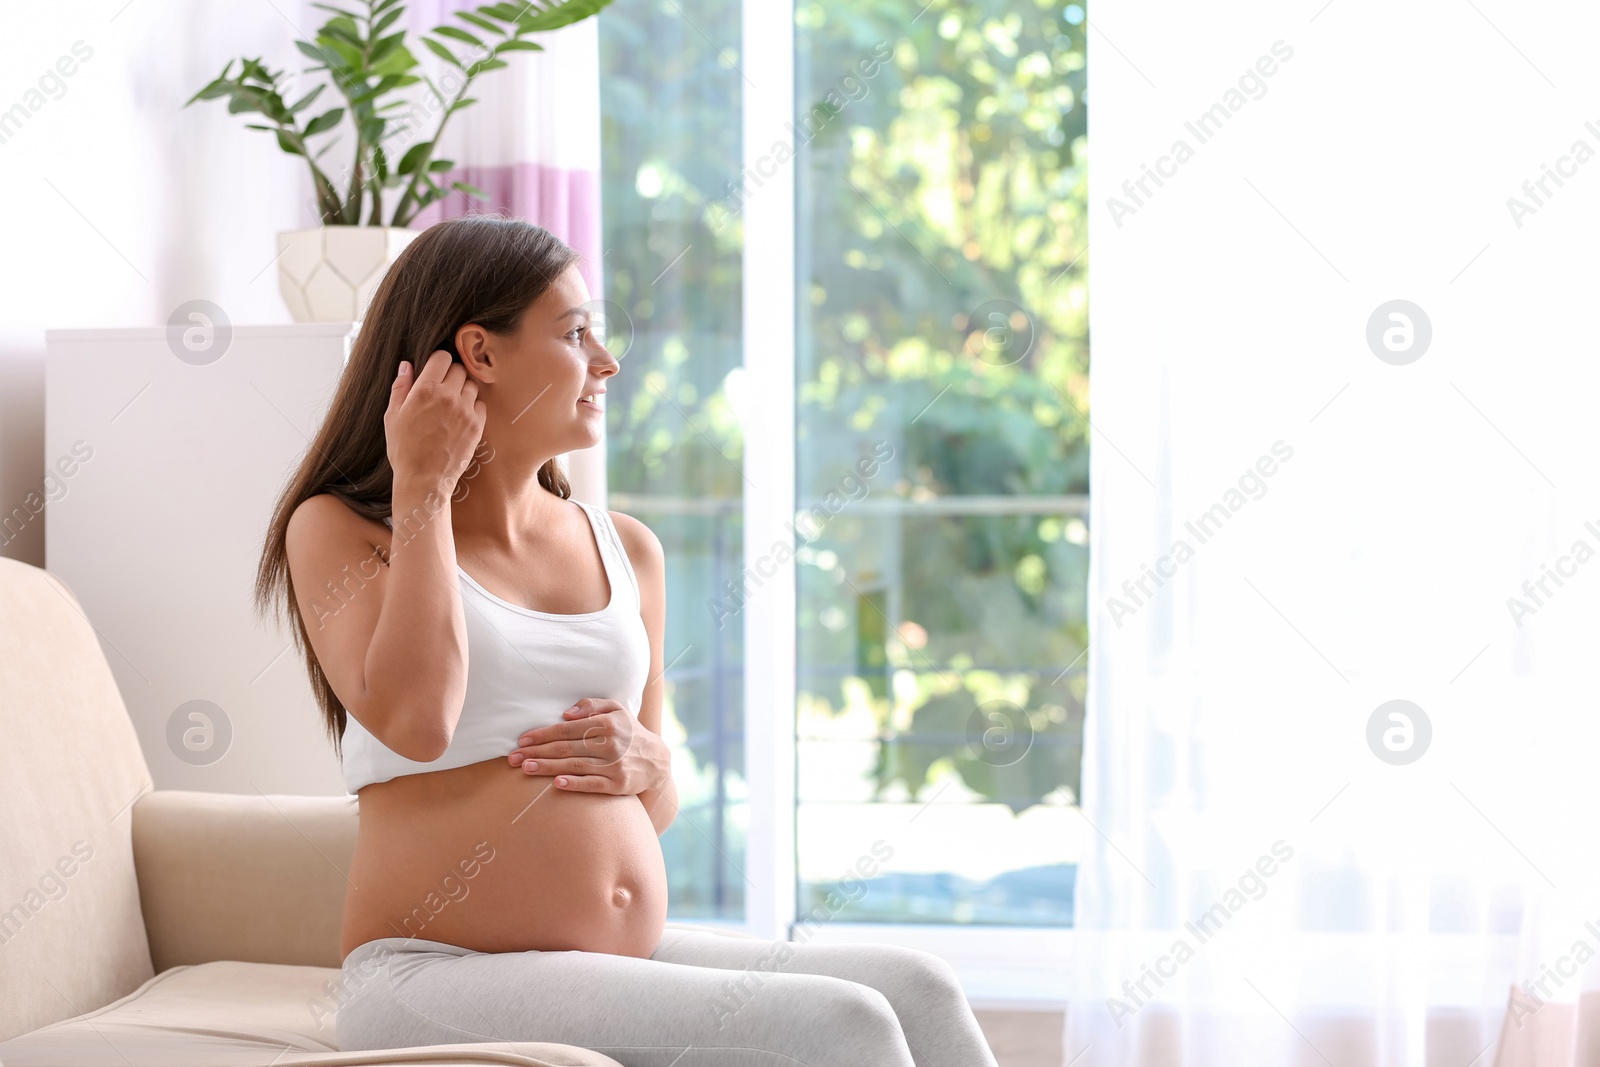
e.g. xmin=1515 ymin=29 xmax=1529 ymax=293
xmin=184 ymin=0 xmax=611 ymax=322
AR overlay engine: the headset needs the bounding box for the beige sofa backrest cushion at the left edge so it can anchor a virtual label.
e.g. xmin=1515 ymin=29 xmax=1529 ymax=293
xmin=0 ymin=558 xmax=154 ymax=1040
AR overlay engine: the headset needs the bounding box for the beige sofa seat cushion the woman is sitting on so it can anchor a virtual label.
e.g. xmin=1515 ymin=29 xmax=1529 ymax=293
xmin=0 ymin=960 xmax=621 ymax=1067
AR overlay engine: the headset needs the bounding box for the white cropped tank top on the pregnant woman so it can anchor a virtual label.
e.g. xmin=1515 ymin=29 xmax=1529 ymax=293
xmin=341 ymin=499 xmax=650 ymax=793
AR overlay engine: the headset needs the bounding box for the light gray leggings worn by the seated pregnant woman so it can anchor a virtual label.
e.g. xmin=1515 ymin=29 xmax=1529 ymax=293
xmin=338 ymin=923 xmax=995 ymax=1067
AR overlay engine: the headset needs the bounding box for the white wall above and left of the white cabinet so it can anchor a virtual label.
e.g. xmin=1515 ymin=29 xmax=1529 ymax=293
xmin=0 ymin=0 xmax=315 ymax=566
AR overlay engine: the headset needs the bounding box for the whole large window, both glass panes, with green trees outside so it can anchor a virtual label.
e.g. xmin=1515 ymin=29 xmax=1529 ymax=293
xmin=600 ymin=0 xmax=1090 ymax=926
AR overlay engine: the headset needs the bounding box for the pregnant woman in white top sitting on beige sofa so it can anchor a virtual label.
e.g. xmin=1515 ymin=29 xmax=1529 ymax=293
xmin=256 ymin=216 xmax=995 ymax=1067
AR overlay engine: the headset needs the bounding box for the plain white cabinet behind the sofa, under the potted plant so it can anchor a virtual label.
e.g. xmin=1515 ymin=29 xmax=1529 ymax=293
xmin=45 ymin=323 xmax=354 ymax=793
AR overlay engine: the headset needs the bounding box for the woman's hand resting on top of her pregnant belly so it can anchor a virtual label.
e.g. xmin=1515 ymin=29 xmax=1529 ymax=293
xmin=507 ymin=696 xmax=672 ymax=797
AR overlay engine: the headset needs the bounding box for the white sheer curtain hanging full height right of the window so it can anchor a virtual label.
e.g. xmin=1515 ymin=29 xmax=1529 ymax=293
xmin=1066 ymin=2 xmax=1600 ymax=1067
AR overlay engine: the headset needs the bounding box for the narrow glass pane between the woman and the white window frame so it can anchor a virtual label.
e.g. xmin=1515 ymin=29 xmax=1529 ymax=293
xmin=600 ymin=0 xmax=746 ymax=920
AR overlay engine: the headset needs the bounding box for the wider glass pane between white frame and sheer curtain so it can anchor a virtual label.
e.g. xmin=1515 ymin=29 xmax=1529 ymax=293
xmin=795 ymin=0 xmax=1088 ymax=925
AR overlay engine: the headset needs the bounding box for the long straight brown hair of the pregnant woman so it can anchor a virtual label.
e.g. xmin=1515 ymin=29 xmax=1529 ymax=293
xmin=254 ymin=214 xmax=579 ymax=758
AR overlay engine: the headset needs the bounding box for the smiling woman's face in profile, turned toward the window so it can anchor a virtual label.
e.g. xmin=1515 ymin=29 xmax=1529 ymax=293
xmin=456 ymin=266 xmax=621 ymax=461
